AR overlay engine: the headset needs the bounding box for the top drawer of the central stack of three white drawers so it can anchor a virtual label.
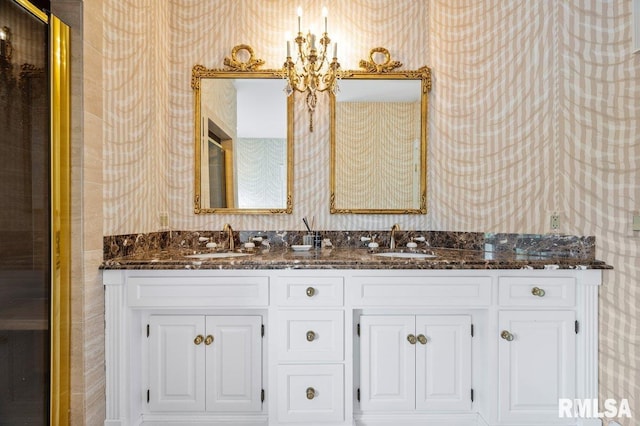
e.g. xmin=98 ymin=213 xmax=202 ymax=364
xmin=275 ymin=277 xmax=344 ymax=306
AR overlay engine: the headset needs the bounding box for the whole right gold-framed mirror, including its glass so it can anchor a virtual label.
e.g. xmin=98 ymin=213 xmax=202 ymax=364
xmin=329 ymin=47 xmax=431 ymax=214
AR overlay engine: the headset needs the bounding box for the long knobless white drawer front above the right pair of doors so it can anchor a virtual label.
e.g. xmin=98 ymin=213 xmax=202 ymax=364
xmin=350 ymin=276 xmax=491 ymax=307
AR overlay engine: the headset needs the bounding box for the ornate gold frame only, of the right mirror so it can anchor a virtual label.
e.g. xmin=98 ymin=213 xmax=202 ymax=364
xmin=329 ymin=47 xmax=431 ymax=214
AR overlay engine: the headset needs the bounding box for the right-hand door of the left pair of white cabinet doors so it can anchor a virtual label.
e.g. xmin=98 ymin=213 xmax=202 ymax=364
xmin=206 ymin=316 xmax=262 ymax=412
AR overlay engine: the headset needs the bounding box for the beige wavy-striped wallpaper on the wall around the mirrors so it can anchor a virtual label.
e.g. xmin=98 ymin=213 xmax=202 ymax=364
xmin=103 ymin=0 xmax=640 ymax=425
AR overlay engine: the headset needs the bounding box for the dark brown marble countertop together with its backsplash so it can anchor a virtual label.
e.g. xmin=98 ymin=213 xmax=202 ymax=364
xmin=101 ymin=230 xmax=612 ymax=270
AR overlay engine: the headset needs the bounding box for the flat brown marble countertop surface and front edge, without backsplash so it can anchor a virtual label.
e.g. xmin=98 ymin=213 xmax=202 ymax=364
xmin=102 ymin=248 xmax=611 ymax=269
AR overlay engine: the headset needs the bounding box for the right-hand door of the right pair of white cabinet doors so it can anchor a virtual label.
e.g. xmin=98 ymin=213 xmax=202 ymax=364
xmin=416 ymin=315 xmax=471 ymax=411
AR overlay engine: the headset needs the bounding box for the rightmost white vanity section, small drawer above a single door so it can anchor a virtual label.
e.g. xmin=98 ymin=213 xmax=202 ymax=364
xmin=496 ymin=274 xmax=584 ymax=424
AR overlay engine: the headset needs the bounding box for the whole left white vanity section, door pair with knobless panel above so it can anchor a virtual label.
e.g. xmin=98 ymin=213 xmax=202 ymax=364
xmin=103 ymin=270 xmax=269 ymax=426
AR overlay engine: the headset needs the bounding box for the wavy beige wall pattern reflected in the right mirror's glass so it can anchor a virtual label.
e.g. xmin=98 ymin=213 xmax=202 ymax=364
xmin=335 ymin=102 xmax=420 ymax=209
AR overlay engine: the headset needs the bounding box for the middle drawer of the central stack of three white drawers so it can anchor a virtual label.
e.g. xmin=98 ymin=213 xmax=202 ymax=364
xmin=278 ymin=311 xmax=344 ymax=361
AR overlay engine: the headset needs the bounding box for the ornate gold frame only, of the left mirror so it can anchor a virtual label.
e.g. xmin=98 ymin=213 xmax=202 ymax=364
xmin=191 ymin=44 xmax=294 ymax=214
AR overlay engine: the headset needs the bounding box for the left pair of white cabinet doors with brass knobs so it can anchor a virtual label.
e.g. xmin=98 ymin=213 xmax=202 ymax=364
xmin=147 ymin=315 xmax=262 ymax=412
